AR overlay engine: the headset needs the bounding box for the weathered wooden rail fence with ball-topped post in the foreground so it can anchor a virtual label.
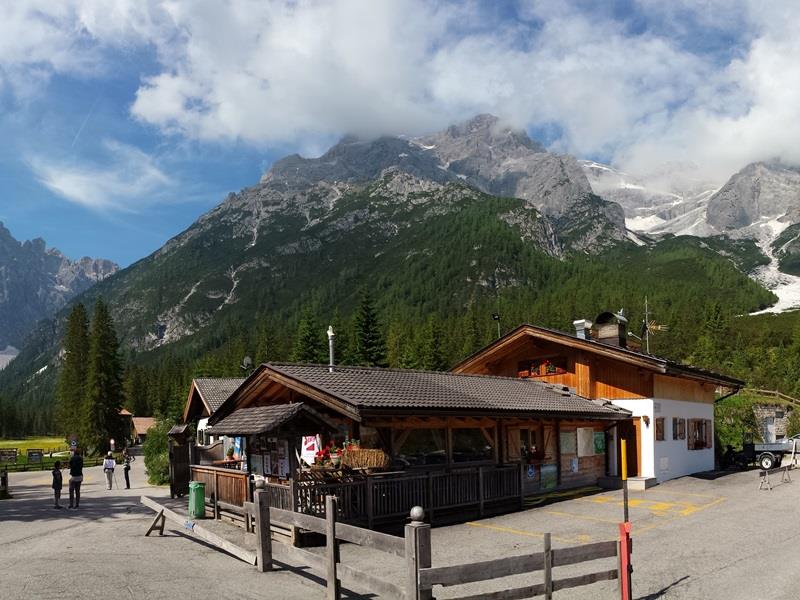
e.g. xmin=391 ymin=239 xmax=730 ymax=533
xmin=142 ymin=489 xmax=631 ymax=600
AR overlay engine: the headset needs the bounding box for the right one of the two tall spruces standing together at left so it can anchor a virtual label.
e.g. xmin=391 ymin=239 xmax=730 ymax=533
xmin=81 ymin=299 xmax=124 ymax=451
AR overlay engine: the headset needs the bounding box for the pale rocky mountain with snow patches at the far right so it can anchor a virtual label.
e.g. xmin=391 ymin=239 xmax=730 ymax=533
xmin=582 ymin=161 xmax=800 ymax=312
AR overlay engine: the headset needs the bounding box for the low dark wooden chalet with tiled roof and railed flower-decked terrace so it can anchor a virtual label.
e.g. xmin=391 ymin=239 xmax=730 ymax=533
xmin=205 ymin=363 xmax=631 ymax=526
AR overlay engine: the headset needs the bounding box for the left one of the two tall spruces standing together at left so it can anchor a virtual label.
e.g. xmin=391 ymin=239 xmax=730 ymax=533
xmin=56 ymin=303 xmax=89 ymax=438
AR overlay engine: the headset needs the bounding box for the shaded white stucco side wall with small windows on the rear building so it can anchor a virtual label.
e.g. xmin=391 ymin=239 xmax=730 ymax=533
xmin=651 ymin=398 xmax=714 ymax=482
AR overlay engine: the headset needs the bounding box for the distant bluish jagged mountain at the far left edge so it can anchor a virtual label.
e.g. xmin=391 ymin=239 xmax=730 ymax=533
xmin=0 ymin=223 xmax=118 ymax=346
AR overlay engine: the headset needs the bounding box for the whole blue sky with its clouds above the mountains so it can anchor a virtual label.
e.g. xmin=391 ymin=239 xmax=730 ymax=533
xmin=0 ymin=0 xmax=800 ymax=265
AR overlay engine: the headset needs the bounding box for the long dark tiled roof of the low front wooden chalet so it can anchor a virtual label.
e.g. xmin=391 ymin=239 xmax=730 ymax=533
xmin=265 ymin=363 xmax=630 ymax=419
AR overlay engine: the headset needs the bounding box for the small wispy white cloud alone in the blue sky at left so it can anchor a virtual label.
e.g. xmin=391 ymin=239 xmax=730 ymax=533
xmin=29 ymin=140 xmax=172 ymax=212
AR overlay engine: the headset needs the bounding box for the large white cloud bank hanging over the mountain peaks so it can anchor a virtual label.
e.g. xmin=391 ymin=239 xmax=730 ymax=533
xmin=0 ymin=0 xmax=800 ymax=181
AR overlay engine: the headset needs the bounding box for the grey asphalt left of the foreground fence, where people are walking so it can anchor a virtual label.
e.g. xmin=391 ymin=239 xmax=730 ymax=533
xmin=0 ymin=458 xmax=324 ymax=600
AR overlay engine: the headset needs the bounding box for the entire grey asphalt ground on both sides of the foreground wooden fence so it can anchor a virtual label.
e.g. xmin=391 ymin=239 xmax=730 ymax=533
xmin=0 ymin=460 xmax=800 ymax=600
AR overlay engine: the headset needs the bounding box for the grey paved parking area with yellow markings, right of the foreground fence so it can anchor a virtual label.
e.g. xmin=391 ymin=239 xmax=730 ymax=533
xmin=343 ymin=471 xmax=800 ymax=600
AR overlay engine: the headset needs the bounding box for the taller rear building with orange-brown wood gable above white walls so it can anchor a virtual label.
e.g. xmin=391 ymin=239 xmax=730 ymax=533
xmin=453 ymin=313 xmax=744 ymax=488
